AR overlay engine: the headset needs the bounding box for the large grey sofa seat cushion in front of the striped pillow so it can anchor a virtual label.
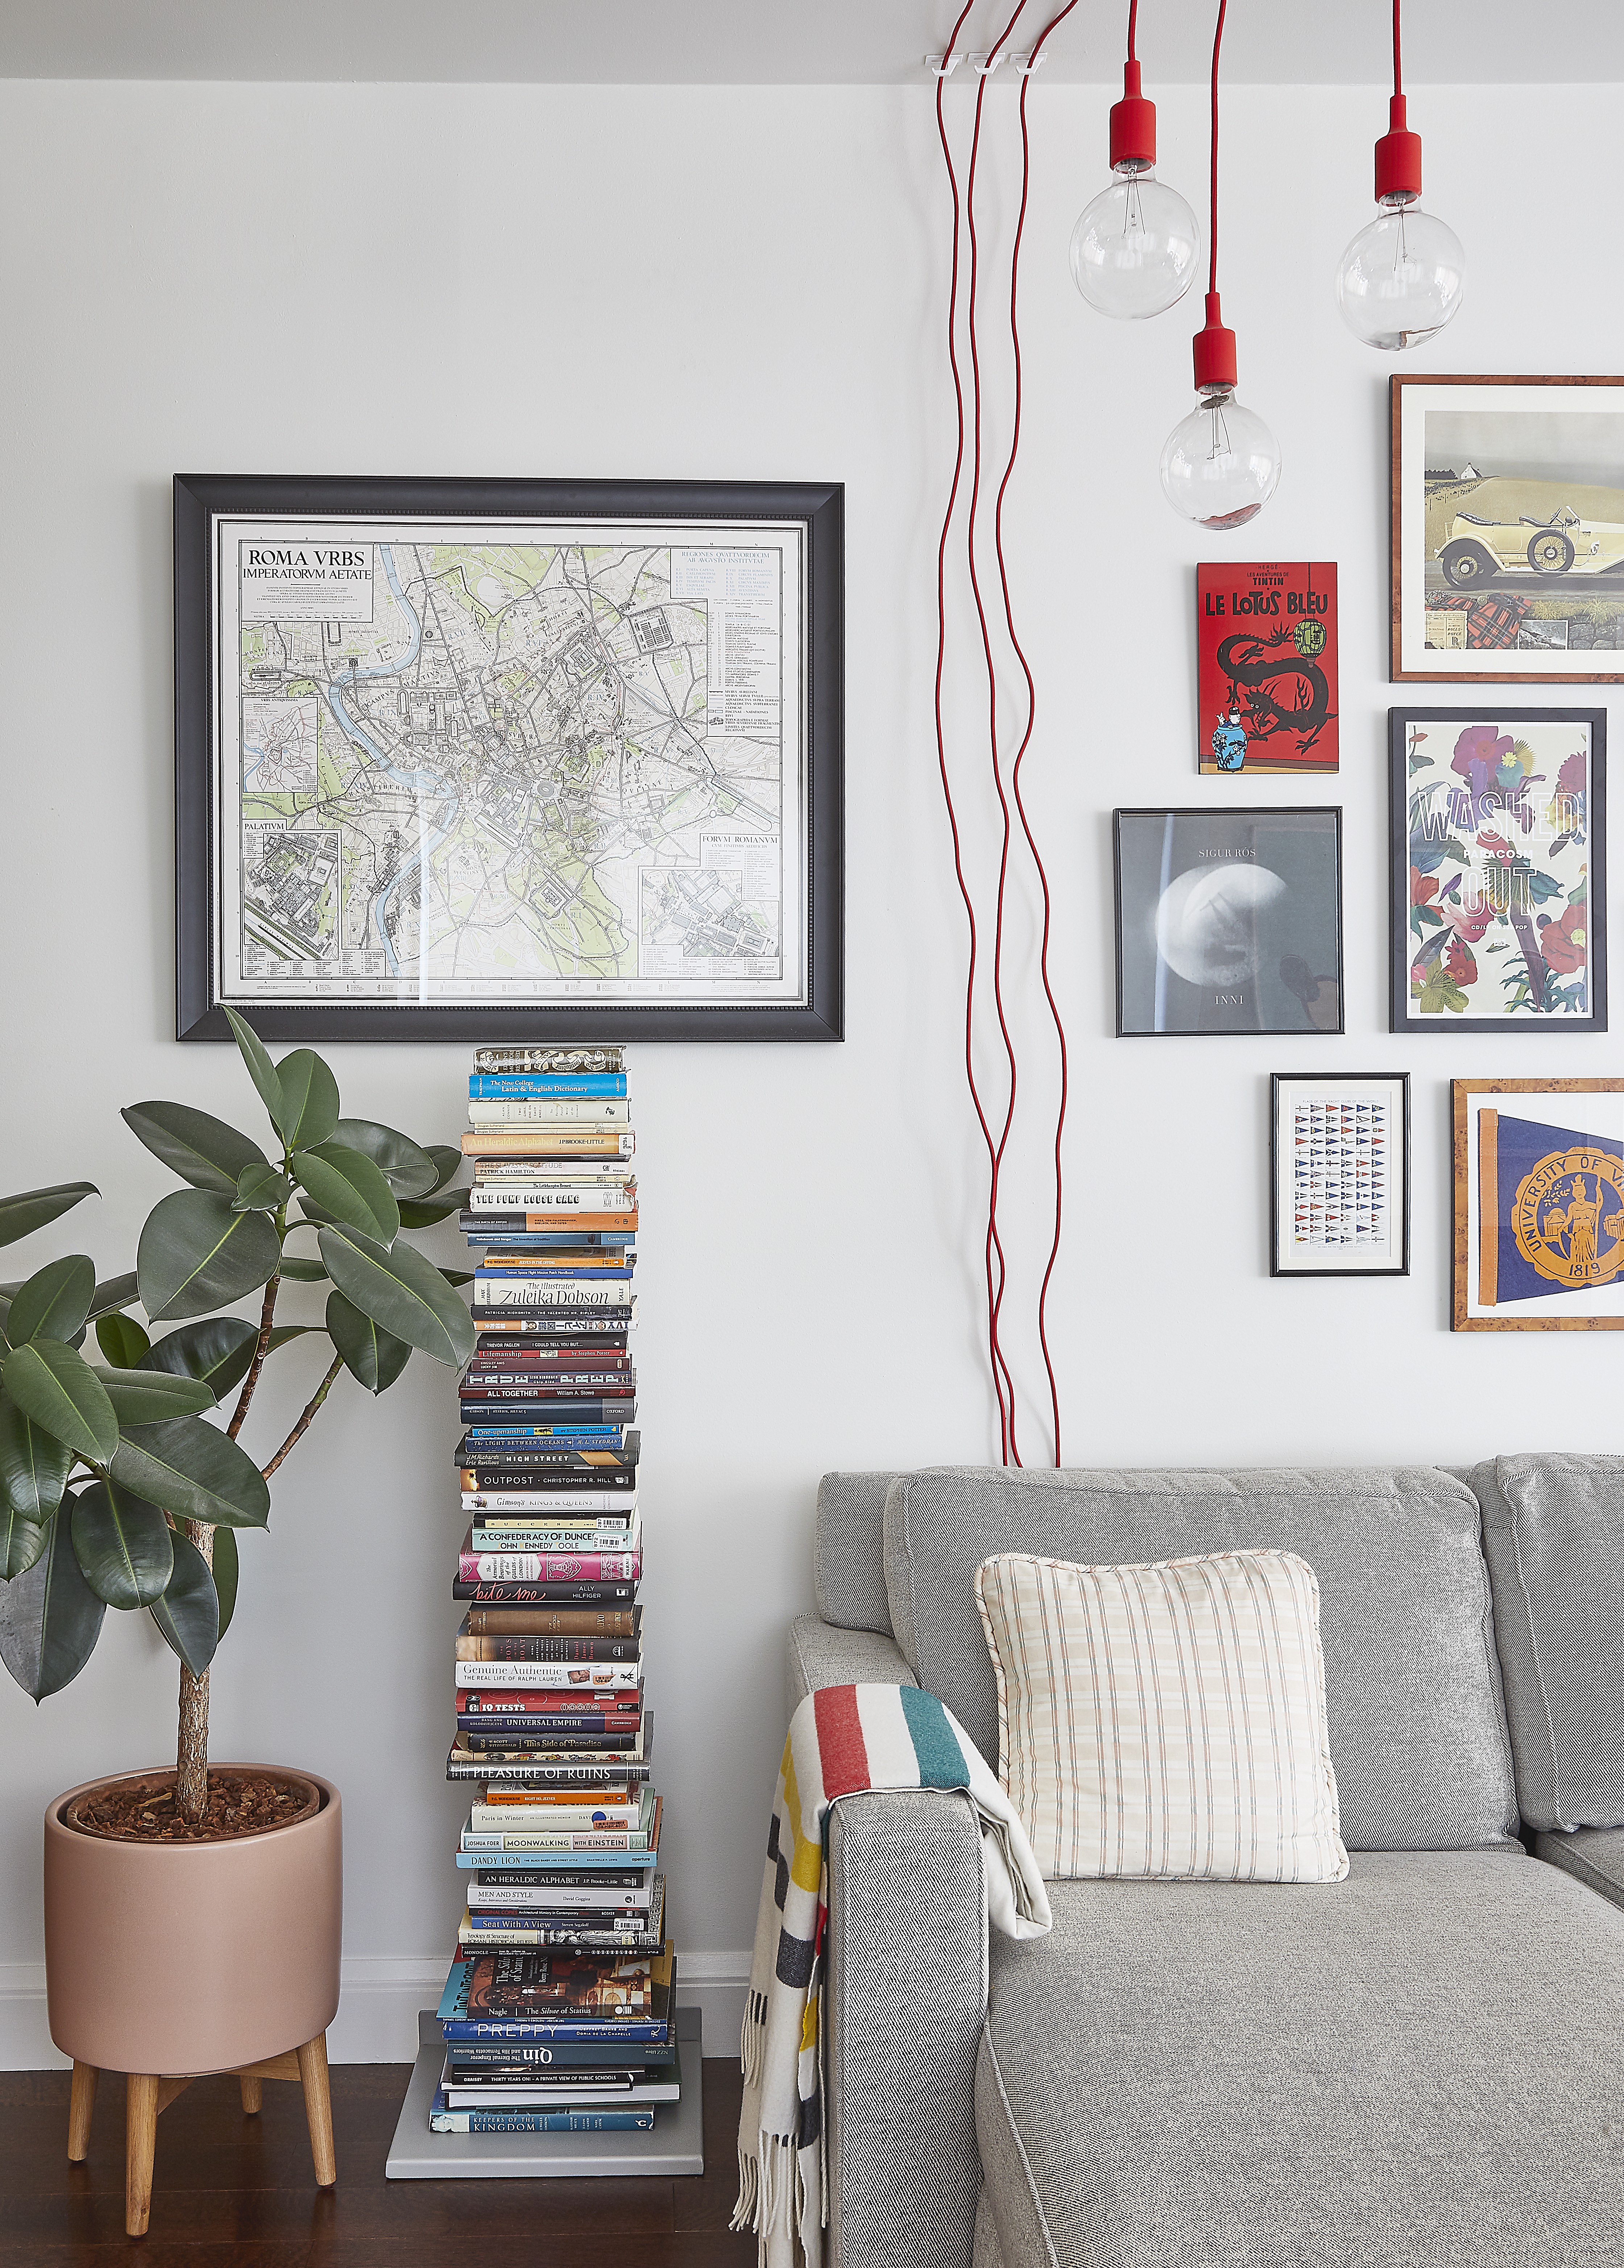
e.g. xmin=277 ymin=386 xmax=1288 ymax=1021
xmin=975 ymin=1848 xmax=1624 ymax=2268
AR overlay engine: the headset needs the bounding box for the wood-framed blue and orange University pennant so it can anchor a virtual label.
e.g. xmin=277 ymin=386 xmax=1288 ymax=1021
xmin=1451 ymin=1079 xmax=1624 ymax=1331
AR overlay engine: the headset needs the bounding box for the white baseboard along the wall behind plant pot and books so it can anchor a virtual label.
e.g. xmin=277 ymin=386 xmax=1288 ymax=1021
xmin=0 ymin=1953 xmax=751 ymax=2071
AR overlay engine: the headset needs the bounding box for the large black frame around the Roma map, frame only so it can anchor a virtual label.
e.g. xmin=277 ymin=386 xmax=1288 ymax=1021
xmin=175 ymin=474 xmax=846 ymax=1046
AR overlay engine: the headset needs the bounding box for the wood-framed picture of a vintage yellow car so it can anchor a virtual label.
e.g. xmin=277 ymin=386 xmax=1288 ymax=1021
xmin=1388 ymin=376 xmax=1624 ymax=685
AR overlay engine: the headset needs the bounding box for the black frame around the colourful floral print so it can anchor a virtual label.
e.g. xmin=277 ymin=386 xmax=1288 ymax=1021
xmin=1388 ymin=703 xmax=1608 ymax=1037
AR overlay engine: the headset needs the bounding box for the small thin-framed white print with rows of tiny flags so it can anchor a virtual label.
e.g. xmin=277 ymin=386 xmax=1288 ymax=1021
xmin=1268 ymin=1070 xmax=1411 ymax=1275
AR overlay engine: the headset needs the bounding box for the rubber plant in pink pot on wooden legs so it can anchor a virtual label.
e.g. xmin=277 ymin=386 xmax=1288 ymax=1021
xmin=0 ymin=1009 xmax=474 ymax=2234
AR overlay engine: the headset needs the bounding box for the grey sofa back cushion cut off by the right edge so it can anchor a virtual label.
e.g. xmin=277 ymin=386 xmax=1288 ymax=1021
xmin=1472 ymin=1456 xmax=1624 ymax=1830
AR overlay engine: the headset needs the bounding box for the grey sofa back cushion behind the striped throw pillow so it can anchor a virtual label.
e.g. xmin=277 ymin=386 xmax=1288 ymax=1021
xmin=884 ymin=1467 xmax=1517 ymax=1851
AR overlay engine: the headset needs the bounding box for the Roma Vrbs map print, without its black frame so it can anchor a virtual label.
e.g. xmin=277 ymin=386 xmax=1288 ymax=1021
xmin=215 ymin=522 xmax=803 ymax=1005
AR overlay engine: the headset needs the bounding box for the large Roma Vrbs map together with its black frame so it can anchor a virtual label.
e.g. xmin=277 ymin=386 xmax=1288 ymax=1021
xmin=175 ymin=474 xmax=844 ymax=1041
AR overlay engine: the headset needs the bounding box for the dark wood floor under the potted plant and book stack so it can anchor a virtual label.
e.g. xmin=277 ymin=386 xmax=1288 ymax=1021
xmin=0 ymin=2057 xmax=755 ymax=2268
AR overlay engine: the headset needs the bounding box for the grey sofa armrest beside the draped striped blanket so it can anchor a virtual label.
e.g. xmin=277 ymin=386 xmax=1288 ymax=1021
xmin=823 ymin=1796 xmax=987 ymax=2268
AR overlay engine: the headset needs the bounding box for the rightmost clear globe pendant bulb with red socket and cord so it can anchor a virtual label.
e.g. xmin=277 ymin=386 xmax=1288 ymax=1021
xmin=1336 ymin=15 xmax=1465 ymax=354
